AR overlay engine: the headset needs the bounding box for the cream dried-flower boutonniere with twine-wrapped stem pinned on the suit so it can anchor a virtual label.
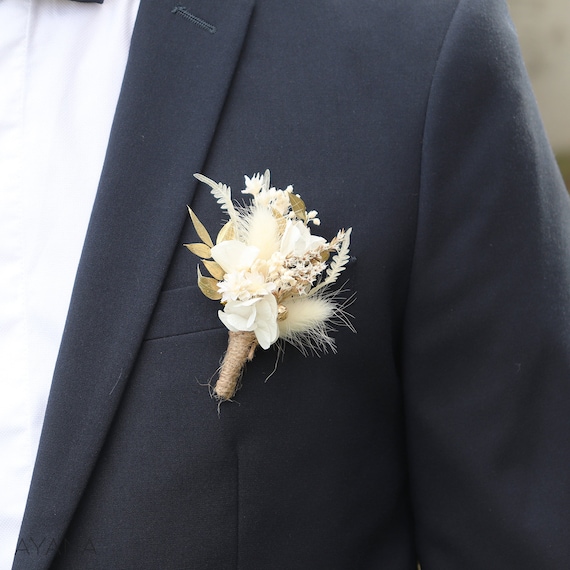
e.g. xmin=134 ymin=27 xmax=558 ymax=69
xmin=185 ymin=171 xmax=354 ymax=400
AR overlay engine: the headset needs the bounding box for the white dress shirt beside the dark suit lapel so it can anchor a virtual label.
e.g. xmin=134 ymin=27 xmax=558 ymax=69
xmin=0 ymin=0 xmax=139 ymax=568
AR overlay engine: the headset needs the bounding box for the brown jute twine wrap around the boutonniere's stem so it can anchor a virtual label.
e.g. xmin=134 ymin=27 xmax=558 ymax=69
xmin=214 ymin=331 xmax=257 ymax=400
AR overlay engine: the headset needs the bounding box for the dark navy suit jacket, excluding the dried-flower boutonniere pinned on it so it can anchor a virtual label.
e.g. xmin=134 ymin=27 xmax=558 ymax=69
xmin=7 ymin=0 xmax=570 ymax=570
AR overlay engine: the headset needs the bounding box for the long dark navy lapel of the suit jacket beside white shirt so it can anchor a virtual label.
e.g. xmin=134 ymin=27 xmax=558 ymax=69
xmin=14 ymin=0 xmax=253 ymax=570
